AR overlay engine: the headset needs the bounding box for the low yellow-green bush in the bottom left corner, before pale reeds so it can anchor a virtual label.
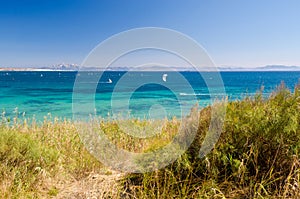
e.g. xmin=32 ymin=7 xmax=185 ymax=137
xmin=0 ymin=128 xmax=58 ymax=197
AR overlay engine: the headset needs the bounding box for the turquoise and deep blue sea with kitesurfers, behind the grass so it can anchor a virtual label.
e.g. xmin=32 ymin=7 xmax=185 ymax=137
xmin=0 ymin=71 xmax=300 ymax=122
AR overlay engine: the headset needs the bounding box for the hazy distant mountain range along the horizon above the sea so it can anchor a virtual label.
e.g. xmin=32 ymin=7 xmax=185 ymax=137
xmin=0 ymin=64 xmax=300 ymax=71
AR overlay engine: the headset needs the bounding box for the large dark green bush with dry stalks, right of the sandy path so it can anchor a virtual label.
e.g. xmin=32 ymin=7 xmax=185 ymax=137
xmin=125 ymin=85 xmax=300 ymax=198
